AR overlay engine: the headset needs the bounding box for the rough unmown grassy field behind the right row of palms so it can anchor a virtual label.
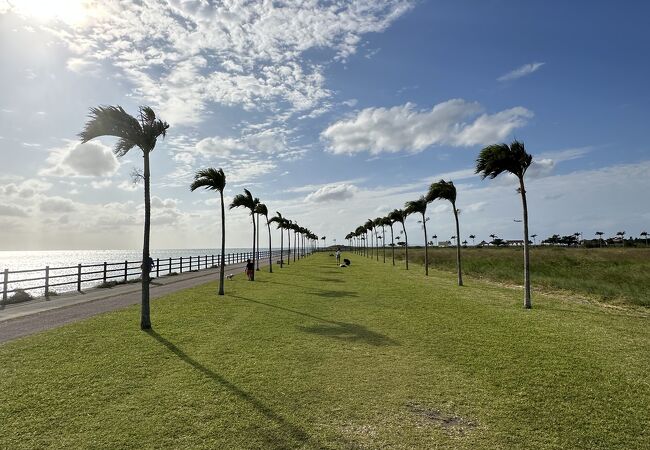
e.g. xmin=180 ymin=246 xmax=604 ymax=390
xmin=379 ymin=247 xmax=650 ymax=307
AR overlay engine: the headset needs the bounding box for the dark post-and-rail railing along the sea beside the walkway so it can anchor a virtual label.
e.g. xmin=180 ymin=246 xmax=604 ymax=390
xmin=0 ymin=249 xmax=302 ymax=305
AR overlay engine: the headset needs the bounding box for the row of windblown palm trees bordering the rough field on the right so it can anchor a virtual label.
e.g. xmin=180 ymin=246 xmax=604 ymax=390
xmin=345 ymin=140 xmax=533 ymax=309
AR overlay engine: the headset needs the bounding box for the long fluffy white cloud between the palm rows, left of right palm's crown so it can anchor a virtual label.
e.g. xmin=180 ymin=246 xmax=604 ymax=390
xmin=321 ymin=99 xmax=533 ymax=155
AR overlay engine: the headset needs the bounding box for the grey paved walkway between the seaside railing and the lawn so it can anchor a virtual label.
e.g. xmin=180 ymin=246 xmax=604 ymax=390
xmin=0 ymin=257 xmax=280 ymax=343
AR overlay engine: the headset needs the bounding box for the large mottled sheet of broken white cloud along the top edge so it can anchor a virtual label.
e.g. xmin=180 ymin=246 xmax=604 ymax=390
xmin=34 ymin=0 xmax=413 ymax=125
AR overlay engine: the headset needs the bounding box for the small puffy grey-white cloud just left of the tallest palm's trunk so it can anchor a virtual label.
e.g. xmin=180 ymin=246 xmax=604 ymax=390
xmin=39 ymin=141 xmax=120 ymax=177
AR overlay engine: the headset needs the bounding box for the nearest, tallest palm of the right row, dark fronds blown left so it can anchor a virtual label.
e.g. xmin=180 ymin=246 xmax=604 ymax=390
xmin=476 ymin=140 xmax=533 ymax=309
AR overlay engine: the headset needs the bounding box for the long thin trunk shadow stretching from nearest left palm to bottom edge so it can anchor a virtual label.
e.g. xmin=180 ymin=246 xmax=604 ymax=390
xmin=146 ymin=330 xmax=322 ymax=448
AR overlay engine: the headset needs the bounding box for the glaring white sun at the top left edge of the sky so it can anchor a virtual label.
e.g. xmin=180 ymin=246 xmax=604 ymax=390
xmin=7 ymin=0 xmax=89 ymax=25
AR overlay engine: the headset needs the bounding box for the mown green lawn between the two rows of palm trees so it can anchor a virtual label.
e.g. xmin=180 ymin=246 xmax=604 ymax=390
xmin=0 ymin=253 xmax=650 ymax=449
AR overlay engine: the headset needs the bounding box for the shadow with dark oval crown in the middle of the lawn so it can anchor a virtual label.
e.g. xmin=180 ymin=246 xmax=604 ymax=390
xmin=230 ymin=294 xmax=400 ymax=347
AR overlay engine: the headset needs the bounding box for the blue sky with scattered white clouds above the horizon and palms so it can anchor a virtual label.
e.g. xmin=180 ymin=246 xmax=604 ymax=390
xmin=0 ymin=0 xmax=650 ymax=250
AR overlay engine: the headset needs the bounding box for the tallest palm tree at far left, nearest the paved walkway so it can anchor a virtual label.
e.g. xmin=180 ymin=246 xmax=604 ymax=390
xmin=79 ymin=106 xmax=169 ymax=330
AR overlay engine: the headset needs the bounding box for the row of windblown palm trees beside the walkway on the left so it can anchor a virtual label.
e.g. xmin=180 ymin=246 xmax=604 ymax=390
xmin=79 ymin=106 xmax=318 ymax=330
